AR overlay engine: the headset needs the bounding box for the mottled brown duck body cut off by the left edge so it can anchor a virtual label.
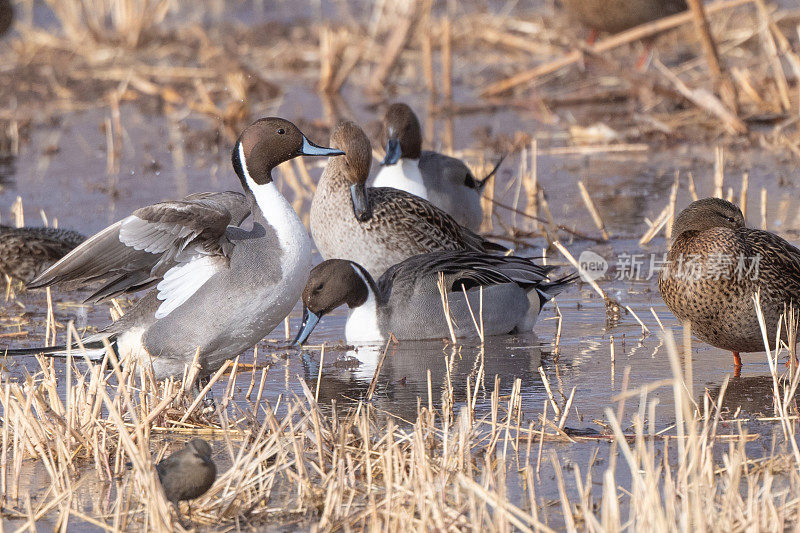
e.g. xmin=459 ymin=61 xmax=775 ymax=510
xmin=0 ymin=226 xmax=86 ymax=283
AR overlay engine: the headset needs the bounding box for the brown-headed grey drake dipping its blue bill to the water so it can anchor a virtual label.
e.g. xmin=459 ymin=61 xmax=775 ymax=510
xmin=296 ymin=251 xmax=574 ymax=343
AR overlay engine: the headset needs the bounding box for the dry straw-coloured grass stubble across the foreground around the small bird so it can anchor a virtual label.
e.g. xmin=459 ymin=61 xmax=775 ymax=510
xmin=0 ymin=312 xmax=800 ymax=531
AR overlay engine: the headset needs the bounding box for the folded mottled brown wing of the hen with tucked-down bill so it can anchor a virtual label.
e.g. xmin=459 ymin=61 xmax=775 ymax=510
xmin=363 ymin=187 xmax=507 ymax=252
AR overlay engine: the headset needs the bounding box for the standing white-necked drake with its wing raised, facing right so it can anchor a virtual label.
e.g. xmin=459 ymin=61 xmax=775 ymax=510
xmin=9 ymin=118 xmax=343 ymax=379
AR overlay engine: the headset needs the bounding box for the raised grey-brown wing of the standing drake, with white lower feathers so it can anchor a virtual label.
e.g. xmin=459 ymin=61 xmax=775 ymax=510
xmin=29 ymin=192 xmax=250 ymax=312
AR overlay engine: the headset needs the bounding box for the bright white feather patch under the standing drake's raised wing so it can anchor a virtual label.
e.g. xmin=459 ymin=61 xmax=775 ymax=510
xmin=156 ymin=255 xmax=227 ymax=319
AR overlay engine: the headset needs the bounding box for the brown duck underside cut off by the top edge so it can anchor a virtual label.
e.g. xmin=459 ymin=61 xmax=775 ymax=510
xmin=563 ymin=0 xmax=688 ymax=33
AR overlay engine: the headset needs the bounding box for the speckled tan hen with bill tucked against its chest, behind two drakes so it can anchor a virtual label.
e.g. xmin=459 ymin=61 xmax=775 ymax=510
xmin=311 ymin=122 xmax=506 ymax=277
